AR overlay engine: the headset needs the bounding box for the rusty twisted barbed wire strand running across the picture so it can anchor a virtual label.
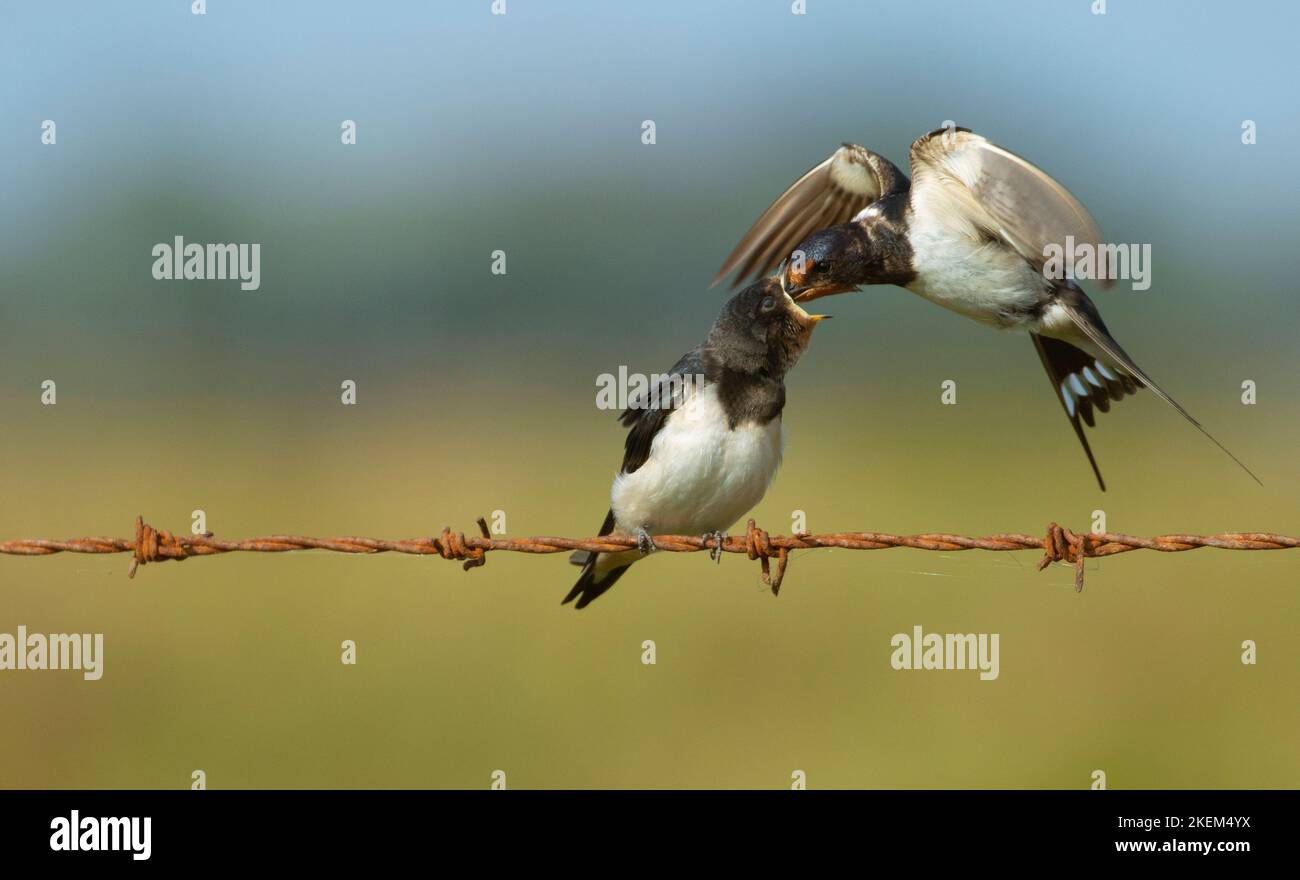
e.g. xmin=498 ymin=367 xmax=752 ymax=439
xmin=0 ymin=516 xmax=1300 ymax=595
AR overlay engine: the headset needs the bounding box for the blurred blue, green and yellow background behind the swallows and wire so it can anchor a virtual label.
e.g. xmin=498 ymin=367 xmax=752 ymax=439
xmin=0 ymin=0 xmax=1300 ymax=788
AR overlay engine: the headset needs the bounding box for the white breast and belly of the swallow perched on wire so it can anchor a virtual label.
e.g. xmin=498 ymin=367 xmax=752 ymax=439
xmin=601 ymin=385 xmax=783 ymax=577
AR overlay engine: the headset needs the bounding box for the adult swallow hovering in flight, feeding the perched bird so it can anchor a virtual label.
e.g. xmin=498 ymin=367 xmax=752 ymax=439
xmin=712 ymin=127 xmax=1258 ymax=491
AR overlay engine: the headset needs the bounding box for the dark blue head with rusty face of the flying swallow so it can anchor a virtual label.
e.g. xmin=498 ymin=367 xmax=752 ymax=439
xmin=781 ymin=210 xmax=914 ymax=303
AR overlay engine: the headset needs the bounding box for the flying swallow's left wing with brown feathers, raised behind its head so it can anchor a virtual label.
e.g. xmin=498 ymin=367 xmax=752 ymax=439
xmin=709 ymin=143 xmax=907 ymax=287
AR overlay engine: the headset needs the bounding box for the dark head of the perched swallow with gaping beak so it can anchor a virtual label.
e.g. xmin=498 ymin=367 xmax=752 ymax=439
xmin=707 ymin=276 xmax=829 ymax=376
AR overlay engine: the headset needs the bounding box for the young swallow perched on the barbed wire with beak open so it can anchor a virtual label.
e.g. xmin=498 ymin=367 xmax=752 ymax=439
xmin=564 ymin=277 xmax=826 ymax=608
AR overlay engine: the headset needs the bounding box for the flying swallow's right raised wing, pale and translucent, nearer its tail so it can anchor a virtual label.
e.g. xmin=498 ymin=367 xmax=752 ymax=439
xmin=911 ymin=129 xmax=1113 ymax=287
